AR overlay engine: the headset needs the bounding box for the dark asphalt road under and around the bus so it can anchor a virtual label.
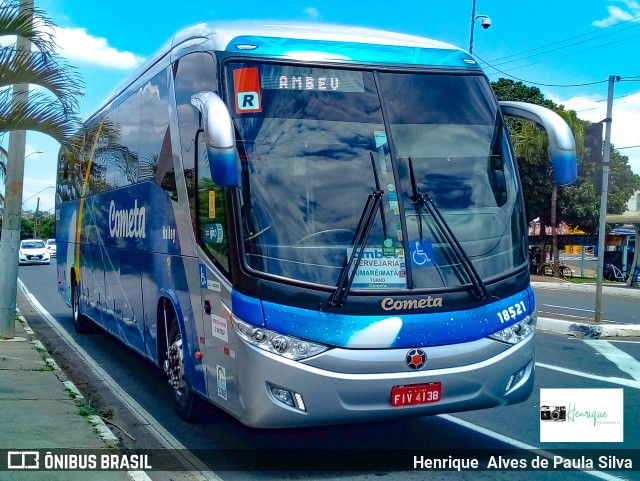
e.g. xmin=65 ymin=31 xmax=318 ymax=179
xmin=13 ymin=263 xmax=640 ymax=481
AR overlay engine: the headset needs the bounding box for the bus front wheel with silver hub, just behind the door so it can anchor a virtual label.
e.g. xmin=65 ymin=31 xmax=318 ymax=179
xmin=164 ymin=316 xmax=195 ymax=421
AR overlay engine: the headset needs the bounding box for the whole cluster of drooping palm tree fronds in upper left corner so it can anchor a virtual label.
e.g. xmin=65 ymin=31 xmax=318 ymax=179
xmin=0 ymin=0 xmax=81 ymax=142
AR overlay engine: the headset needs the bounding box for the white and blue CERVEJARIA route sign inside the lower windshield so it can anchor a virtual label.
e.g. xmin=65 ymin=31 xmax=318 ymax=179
xmin=347 ymin=247 xmax=407 ymax=289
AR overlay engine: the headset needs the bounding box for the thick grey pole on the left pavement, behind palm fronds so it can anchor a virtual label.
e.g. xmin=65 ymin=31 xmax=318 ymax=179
xmin=0 ymin=0 xmax=33 ymax=339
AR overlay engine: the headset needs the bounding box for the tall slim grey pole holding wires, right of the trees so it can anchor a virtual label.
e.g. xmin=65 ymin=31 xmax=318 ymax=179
xmin=594 ymin=75 xmax=620 ymax=322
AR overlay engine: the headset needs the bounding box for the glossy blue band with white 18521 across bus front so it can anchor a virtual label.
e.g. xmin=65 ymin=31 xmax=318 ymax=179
xmin=249 ymin=288 xmax=533 ymax=349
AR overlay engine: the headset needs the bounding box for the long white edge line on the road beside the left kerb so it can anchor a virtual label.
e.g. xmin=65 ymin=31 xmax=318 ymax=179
xmin=18 ymin=278 xmax=222 ymax=481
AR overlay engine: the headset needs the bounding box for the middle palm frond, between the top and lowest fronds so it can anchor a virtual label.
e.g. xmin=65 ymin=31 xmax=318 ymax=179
xmin=0 ymin=47 xmax=81 ymax=114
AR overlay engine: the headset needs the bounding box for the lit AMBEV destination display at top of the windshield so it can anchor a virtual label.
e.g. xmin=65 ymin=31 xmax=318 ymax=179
xmin=258 ymin=65 xmax=364 ymax=92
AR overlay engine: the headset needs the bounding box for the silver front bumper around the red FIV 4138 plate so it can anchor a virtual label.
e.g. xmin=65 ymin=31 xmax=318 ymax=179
xmin=236 ymin=335 xmax=535 ymax=428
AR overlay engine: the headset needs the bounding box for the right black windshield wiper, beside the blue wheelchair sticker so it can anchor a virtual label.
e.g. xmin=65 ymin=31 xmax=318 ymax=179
xmin=409 ymin=157 xmax=489 ymax=299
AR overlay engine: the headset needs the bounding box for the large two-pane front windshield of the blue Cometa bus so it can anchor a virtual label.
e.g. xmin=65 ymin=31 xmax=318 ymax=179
xmin=226 ymin=62 xmax=526 ymax=291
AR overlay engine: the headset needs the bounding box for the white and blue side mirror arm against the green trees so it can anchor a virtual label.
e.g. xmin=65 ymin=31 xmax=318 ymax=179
xmin=500 ymin=101 xmax=578 ymax=186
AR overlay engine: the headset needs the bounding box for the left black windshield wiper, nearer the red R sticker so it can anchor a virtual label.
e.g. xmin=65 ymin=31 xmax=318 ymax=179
xmin=328 ymin=152 xmax=387 ymax=307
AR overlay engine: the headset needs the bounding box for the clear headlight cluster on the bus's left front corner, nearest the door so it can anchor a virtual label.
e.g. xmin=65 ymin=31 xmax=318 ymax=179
xmin=231 ymin=316 xmax=328 ymax=361
